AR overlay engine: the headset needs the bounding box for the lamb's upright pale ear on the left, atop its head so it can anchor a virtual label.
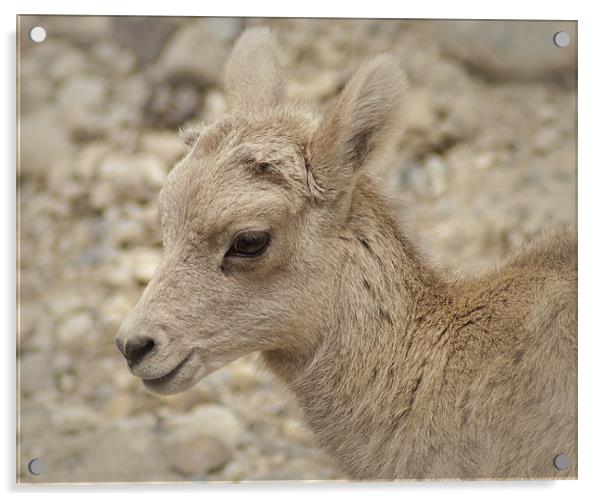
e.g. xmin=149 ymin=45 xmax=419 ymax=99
xmin=225 ymin=28 xmax=284 ymax=110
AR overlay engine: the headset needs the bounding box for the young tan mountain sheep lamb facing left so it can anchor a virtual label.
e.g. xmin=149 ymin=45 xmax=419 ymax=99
xmin=116 ymin=28 xmax=577 ymax=479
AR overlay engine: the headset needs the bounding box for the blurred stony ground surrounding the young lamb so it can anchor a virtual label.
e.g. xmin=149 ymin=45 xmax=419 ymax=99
xmin=18 ymin=16 xmax=577 ymax=482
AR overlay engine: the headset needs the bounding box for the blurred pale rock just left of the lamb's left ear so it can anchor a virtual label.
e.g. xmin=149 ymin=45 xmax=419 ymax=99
xmin=156 ymin=18 xmax=240 ymax=87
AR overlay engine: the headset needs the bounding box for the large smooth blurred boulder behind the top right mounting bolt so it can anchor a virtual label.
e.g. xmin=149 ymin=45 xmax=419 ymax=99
xmin=428 ymin=21 xmax=577 ymax=80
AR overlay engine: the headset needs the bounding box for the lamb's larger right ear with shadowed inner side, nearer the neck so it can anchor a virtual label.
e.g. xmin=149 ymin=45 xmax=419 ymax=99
xmin=309 ymin=54 xmax=408 ymax=201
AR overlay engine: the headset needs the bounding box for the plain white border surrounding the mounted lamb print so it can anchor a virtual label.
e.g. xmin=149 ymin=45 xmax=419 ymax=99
xmin=0 ymin=0 xmax=602 ymax=501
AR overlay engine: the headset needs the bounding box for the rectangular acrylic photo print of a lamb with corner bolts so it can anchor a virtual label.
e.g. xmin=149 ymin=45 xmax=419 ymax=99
xmin=17 ymin=16 xmax=577 ymax=483
